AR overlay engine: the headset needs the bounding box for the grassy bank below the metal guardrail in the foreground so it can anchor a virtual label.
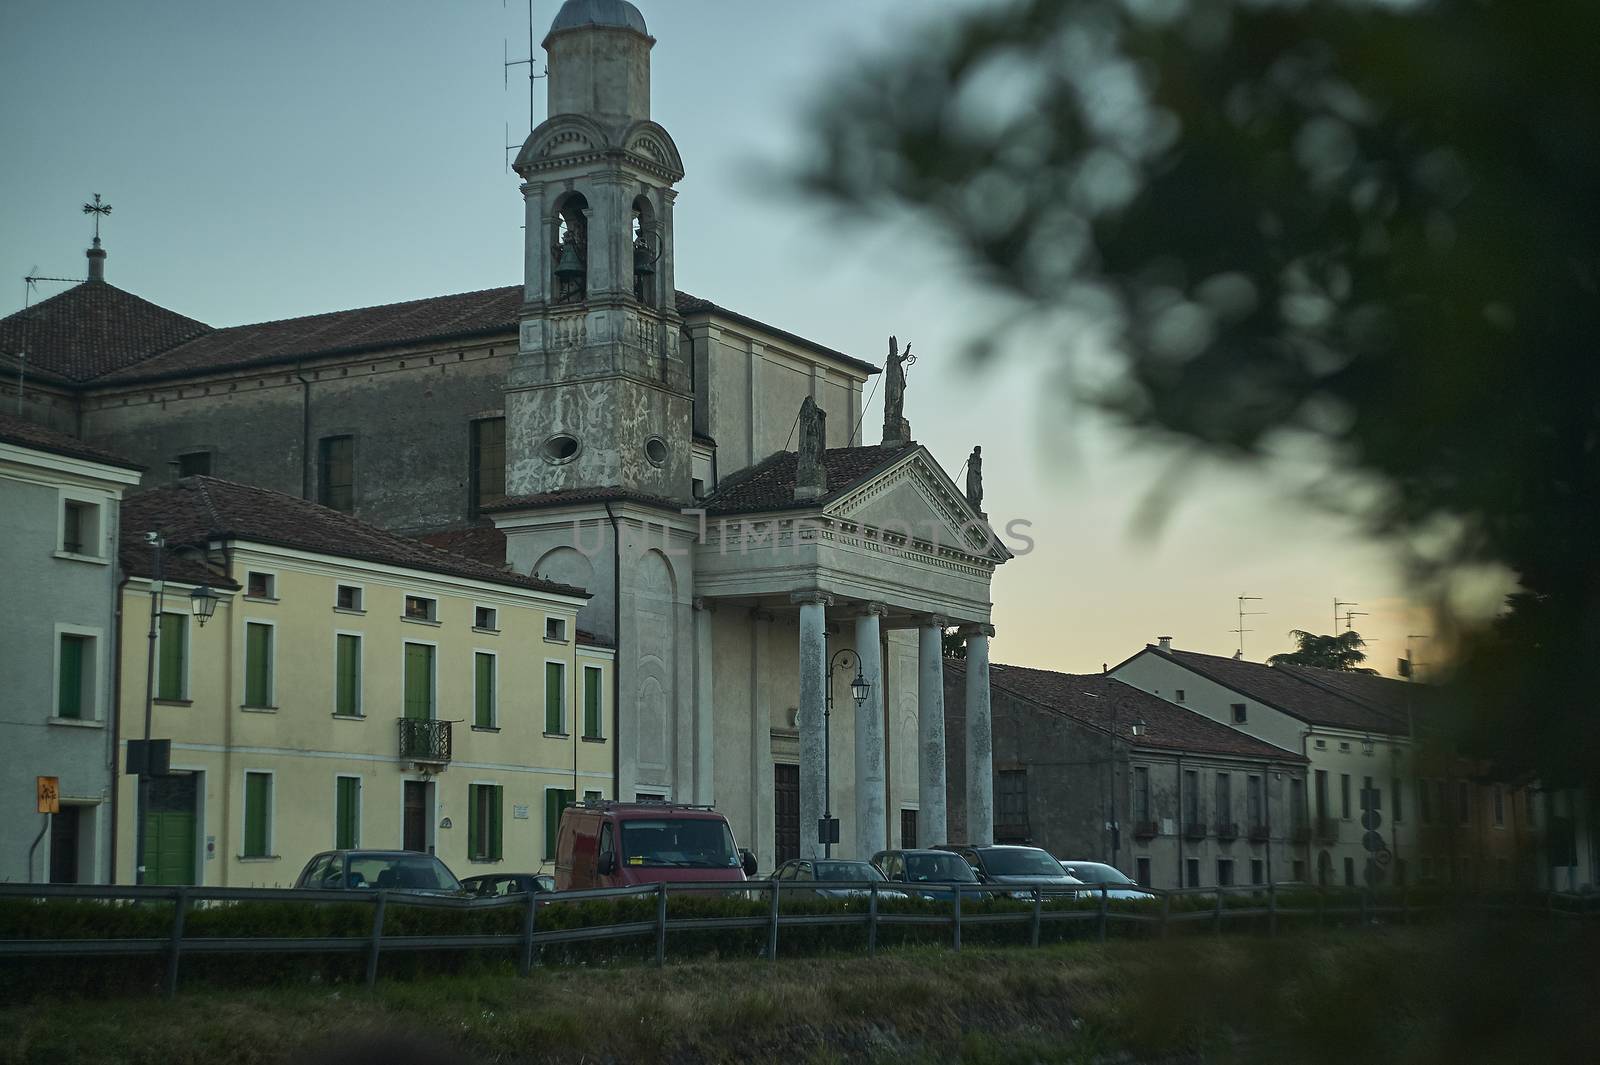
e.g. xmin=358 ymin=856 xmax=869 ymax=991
xmin=0 ymin=924 xmax=1600 ymax=1065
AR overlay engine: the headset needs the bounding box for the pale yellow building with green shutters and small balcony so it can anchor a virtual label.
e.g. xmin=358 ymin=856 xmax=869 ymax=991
xmin=115 ymin=477 xmax=614 ymax=888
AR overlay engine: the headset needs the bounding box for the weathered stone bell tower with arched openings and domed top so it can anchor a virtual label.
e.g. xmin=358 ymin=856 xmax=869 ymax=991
xmin=506 ymin=0 xmax=693 ymax=501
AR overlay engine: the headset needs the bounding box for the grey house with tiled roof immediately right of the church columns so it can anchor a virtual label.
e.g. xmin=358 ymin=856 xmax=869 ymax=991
xmin=926 ymin=662 xmax=1306 ymax=888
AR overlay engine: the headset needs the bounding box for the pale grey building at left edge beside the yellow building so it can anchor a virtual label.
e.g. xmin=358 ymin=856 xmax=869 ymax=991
xmin=0 ymin=414 xmax=141 ymax=884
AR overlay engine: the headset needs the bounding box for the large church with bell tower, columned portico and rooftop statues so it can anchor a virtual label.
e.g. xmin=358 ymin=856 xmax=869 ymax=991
xmin=0 ymin=0 xmax=1010 ymax=868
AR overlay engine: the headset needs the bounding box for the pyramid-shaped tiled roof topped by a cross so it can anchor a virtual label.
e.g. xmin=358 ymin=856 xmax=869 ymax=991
xmin=0 ymin=281 xmax=211 ymax=382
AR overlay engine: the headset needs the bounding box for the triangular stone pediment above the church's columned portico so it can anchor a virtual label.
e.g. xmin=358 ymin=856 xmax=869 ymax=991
xmin=822 ymin=448 xmax=1011 ymax=563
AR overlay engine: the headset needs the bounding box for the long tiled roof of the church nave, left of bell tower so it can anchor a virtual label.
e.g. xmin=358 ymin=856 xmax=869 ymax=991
xmin=95 ymin=285 xmax=522 ymax=384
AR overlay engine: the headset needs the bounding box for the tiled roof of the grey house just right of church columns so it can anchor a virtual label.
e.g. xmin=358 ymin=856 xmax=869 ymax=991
xmin=944 ymin=659 xmax=1306 ymax=763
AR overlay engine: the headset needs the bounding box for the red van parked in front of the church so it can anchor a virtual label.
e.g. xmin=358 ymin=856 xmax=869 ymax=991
xmin=555 ymin=800 xmax=755 ymax=891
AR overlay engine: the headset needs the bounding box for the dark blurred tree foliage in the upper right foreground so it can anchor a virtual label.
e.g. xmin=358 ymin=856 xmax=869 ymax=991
xmin=806 ymin=0 xmax=1600 ymax=776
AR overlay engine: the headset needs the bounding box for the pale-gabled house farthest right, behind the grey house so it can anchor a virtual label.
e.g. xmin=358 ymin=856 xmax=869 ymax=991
xmin=1110 ymin=638 xmax=1536 ymax=889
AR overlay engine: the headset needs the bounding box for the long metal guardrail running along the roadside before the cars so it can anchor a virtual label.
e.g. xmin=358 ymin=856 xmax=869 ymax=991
xmin=0 ymin=880 xmax=1600 ymax=995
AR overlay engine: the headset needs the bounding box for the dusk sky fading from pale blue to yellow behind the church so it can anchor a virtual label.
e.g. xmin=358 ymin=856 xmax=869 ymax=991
xmin=0 ymin=0 xmax=1432 ymax=675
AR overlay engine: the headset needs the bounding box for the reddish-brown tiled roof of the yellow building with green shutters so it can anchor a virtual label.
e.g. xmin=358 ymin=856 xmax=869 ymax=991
xmin=122 ymin=477 xmax=587 ymax=598
